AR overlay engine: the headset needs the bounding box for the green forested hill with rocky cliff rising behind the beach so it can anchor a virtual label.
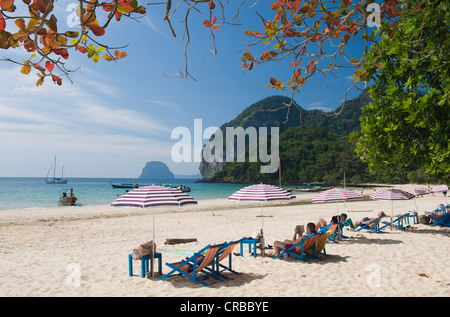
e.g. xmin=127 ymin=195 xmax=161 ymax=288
xmin=200 ymin=90 xmax=423 ymax=183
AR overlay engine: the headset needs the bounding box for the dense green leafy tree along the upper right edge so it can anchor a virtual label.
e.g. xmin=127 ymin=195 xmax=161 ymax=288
xmin=353 ymin=0 xmax=450 ymax=181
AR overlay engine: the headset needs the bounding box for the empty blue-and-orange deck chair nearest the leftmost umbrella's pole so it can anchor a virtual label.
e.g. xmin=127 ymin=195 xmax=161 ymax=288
xmin=159 ymin=244 xmax=224 ymax=286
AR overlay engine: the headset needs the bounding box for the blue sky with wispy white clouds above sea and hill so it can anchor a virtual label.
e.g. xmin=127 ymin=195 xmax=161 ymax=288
xmin=0 ymin=1 xmax=370 ymax=178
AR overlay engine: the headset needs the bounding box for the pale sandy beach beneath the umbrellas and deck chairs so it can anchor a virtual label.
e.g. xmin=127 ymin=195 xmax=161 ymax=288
xmin=0 ymin=185 xmax=450 ymax=297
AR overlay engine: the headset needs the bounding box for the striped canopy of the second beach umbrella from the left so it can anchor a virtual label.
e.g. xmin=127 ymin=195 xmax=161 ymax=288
xmin=228 ymin=184 xmax=295 ymax=201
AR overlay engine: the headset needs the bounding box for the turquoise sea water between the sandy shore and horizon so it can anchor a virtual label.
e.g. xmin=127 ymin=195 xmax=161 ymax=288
xmin=0 ymin=177 xmax=256 ymax=210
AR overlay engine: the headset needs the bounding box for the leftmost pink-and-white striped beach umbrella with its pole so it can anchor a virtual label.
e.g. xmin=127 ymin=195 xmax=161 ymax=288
xmin=111 ymin=186 xmax=197 ymax=277
